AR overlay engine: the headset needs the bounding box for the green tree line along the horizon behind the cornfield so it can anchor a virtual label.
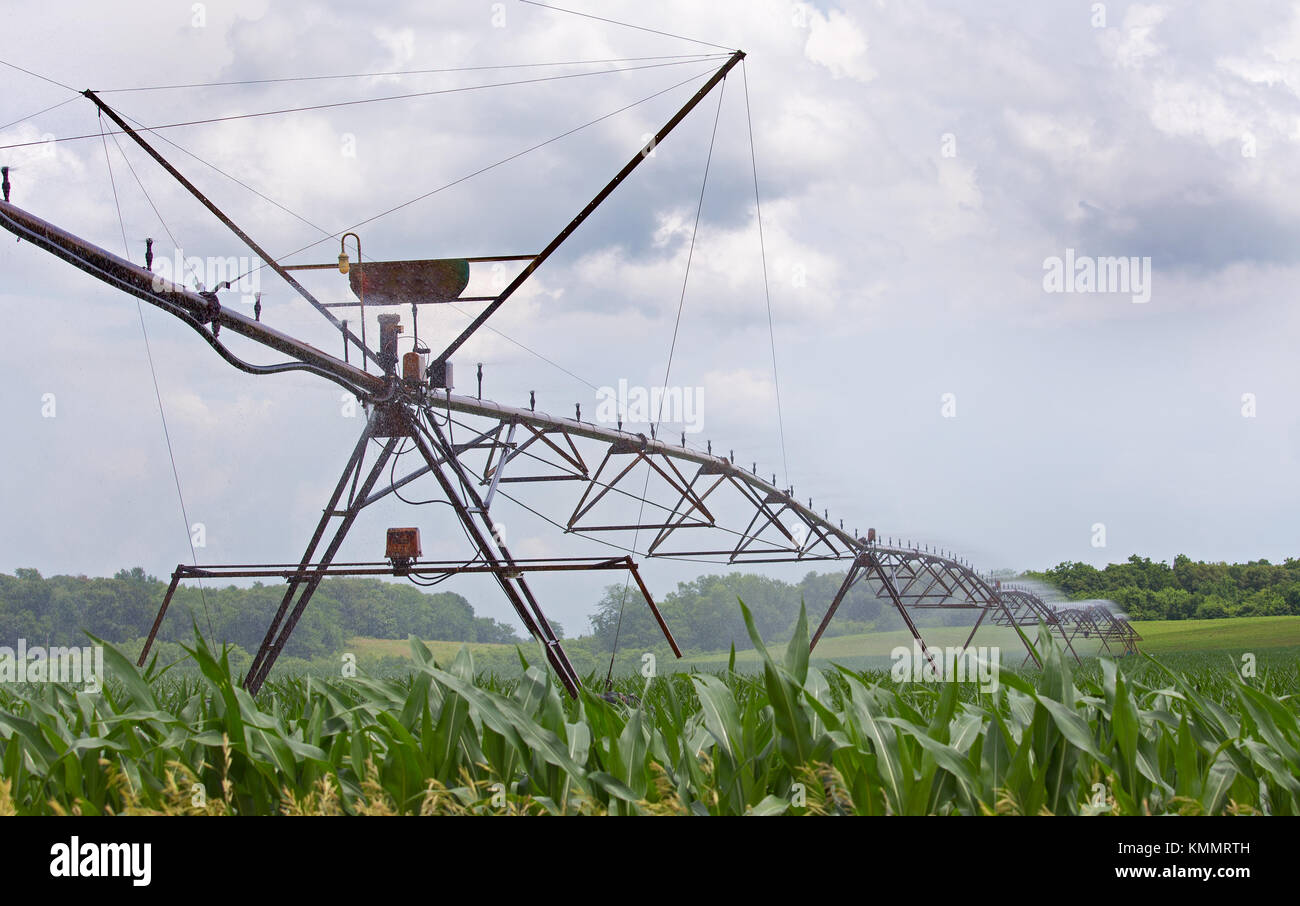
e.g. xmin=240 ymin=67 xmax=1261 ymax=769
xmin=0 ymin=555 xmax=1300 ymax=659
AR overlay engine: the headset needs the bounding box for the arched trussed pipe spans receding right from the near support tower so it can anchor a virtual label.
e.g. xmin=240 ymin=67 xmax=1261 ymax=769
xmin=430 ymin=393 xmax=1136 ymax=660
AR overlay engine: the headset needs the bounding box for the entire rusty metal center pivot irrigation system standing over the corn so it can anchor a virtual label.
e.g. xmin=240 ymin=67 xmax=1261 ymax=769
xmin=0 ymin=51 xmax=1140 ymax=695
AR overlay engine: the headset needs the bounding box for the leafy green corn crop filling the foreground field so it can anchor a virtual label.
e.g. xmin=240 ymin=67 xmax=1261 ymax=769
xmin=0 ymin=604 xmax=1300 ymax=815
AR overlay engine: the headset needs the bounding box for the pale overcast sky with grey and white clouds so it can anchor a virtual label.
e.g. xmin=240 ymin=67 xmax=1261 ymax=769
xmin=0 ymin=0 xmax=1300 ymax=632
